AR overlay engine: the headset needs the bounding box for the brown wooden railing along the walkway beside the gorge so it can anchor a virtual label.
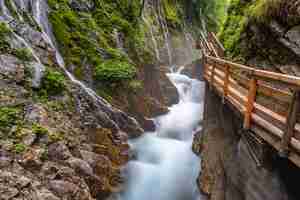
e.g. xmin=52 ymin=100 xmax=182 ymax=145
xmin=199 ymin=33 xmax=300 ymax=167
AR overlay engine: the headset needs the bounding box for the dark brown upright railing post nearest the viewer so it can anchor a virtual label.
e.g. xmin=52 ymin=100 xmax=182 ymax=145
xmin=280 ymin=91 xmax=300 ymax=157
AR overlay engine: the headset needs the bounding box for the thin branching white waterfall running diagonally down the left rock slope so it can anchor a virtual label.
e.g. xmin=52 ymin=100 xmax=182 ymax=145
xmin=0 ymin=0 xmax=142 ymax=132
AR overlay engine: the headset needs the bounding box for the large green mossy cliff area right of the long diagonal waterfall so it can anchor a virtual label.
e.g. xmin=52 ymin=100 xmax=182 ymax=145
xmin=48 ymin=0 xmax=144 ymax=84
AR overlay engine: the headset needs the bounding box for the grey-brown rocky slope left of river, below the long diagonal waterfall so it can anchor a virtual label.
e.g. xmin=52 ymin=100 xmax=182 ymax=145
xmin=0 ymin=0 xmax=143 ymax=200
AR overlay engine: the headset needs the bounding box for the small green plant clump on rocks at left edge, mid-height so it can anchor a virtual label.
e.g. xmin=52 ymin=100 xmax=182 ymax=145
xmin=0 ymin=107 xmax=20 ymax=131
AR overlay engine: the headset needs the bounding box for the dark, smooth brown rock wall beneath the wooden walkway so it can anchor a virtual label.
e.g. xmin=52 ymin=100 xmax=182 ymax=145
xmin=193 ymin=84 xmax=299 ymax=200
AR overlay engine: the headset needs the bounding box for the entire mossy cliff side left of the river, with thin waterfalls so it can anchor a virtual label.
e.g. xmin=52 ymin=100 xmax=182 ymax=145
xmin=0 ymin=0 xmax=206 ymax=200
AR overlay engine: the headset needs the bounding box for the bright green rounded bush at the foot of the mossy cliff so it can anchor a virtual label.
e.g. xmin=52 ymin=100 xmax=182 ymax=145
xmin=95 ymin=60 xmax=136 ymax=82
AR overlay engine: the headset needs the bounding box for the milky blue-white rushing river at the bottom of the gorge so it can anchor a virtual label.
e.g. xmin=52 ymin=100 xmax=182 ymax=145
xmin=122 ymin=67 xmax=204 ymax=200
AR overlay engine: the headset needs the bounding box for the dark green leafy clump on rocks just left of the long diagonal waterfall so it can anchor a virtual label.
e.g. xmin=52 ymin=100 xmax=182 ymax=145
xmin=40 ymin=68 xmax=65 ymax=96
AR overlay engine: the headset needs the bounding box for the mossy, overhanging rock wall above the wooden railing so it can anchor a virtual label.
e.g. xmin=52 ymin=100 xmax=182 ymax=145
xmin=218 ymin=0 xmax=300 ymax=76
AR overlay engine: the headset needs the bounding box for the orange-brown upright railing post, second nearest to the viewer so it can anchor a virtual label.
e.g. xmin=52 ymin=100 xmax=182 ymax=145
xmin=244 ymin=76 xmax=257 ymax=130
